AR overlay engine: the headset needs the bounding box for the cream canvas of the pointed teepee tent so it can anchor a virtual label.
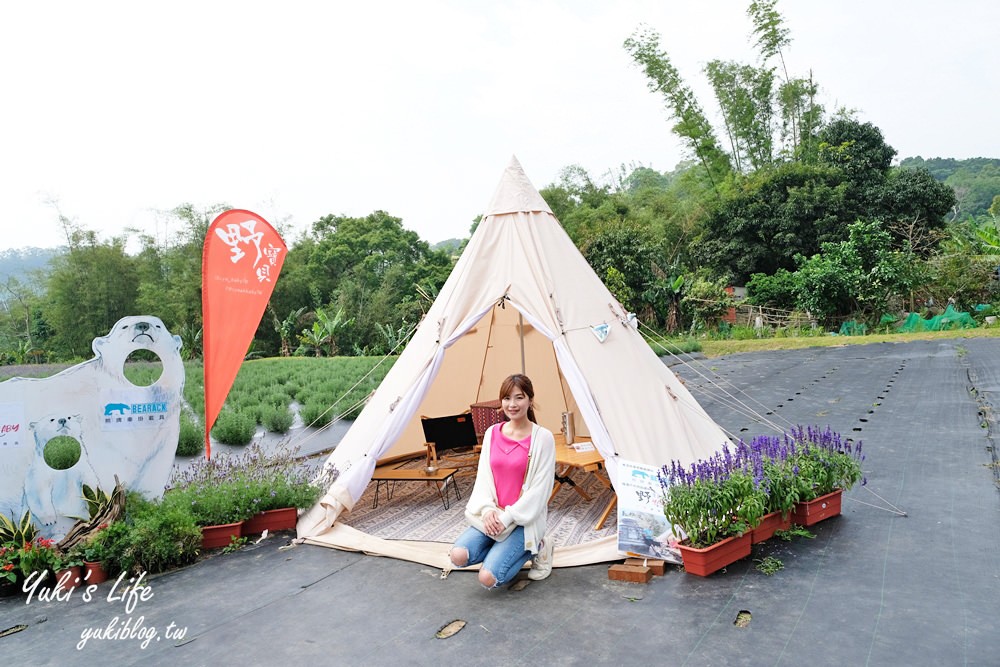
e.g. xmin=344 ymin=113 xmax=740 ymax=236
xmin=298 ymin=158 xmax=728 ymax=569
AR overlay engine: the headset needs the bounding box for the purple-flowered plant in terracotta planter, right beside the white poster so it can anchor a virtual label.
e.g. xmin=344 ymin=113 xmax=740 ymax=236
xmin=659 ymin=446 xmax=766 ymax=576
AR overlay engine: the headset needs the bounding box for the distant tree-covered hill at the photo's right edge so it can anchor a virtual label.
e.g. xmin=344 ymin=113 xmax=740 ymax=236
xmin=899 ymin=156 xmax=1000 ymax=220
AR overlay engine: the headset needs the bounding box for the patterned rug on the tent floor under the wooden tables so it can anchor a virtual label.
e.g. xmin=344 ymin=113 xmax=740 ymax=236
xmin=341 ymin=459 xmax=617 ymax=547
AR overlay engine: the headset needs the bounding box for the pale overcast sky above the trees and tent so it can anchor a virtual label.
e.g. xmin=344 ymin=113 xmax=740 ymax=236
xmin=0 ymin=0 xmax=1000 ymax=250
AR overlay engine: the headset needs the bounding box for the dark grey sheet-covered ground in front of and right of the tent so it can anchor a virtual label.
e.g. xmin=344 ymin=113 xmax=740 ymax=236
xmin=0 ymin=338 xmax=1000 ymax=666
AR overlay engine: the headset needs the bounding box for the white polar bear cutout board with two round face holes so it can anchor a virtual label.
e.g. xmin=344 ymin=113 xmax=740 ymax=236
xmin=0 ymin=315 xmax=184 ymax=539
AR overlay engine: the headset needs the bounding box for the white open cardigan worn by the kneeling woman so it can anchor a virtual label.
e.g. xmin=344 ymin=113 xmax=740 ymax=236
xmin=465 ymin=424 xmax=556 ymax=554
